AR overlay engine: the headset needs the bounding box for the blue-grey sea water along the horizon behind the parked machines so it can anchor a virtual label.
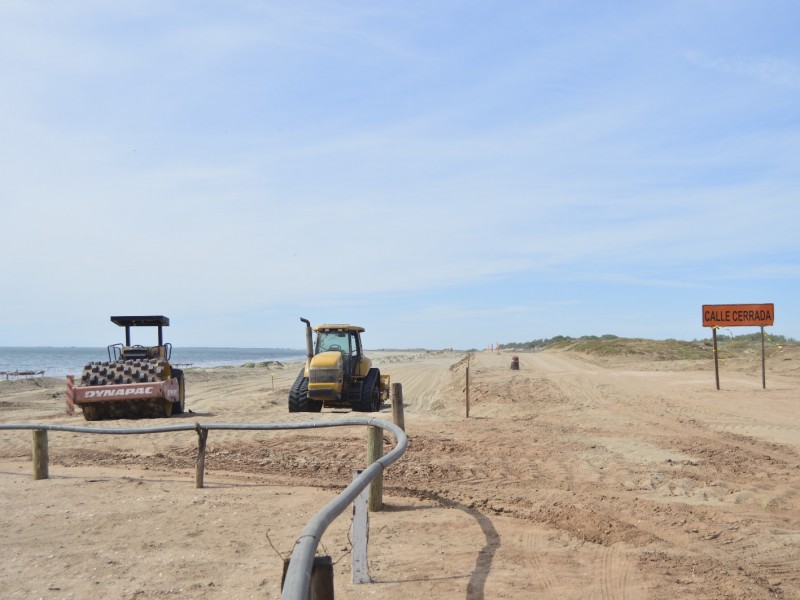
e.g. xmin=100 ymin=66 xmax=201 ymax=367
xmin=0 ymin=346 xmax=305 ymax=379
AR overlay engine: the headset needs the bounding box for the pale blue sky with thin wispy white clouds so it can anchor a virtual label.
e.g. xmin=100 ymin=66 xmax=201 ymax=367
xmin=0 ymin=0 xmax=800 ymax=348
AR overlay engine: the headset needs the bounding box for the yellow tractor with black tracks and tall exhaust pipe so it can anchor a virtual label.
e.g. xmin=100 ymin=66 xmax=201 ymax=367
xmin=289 ymin=318 xmax=390 ymax=412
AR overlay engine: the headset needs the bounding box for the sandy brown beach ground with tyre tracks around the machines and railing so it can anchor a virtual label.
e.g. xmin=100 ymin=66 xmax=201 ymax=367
xmin=0 ymin=346 xmax=800 ymax=600
